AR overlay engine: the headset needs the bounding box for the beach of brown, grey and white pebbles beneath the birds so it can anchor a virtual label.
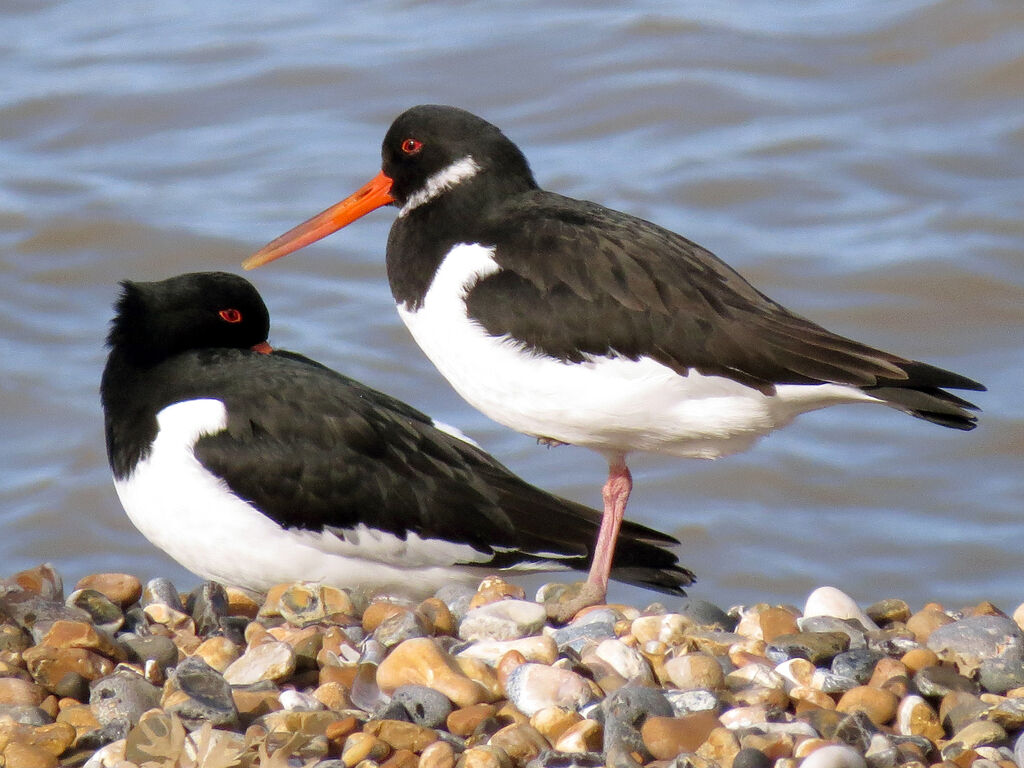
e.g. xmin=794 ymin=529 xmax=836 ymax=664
xmin=0 ymin=565 xmax=1024 ymax=768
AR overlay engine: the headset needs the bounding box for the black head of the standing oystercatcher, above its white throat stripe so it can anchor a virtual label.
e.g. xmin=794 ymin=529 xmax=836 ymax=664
xmin=381 ymin=104 xmax=537 ymax=206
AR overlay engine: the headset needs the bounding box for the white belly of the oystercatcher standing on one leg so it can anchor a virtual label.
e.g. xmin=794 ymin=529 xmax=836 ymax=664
xmin=398 ymin=245 xmax=879 ymax=459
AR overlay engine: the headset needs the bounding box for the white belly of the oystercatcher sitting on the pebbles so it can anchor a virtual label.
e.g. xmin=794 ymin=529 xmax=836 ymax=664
xmin=115 ymin=399 xmax=487 ymax=595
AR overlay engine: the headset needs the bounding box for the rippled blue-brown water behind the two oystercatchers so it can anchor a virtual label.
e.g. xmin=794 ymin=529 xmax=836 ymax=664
xmin=0 ymin=0 xmax=1024 ymax=610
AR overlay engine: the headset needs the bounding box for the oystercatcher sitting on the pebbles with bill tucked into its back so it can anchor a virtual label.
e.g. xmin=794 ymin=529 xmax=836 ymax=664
xmin=100 ymin=272 xmax=693 ymax=595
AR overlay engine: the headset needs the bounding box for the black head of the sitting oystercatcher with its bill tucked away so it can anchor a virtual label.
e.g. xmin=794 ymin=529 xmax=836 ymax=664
xmin=106 ymin=272 xmax=270 ymax=364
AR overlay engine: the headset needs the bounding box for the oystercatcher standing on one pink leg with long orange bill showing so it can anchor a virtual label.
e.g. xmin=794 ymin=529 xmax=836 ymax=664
xmin=245 ymin=105 xmax=984 ymax=589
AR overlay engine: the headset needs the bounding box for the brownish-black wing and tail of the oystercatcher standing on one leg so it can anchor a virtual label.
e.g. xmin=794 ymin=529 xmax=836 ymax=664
xmin=467 ymin=190 xmax=984 ymax=428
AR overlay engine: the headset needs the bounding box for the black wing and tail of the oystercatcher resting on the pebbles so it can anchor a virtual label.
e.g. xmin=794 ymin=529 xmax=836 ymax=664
xmin=181 ymin=350 xmax=692 ymax=593
